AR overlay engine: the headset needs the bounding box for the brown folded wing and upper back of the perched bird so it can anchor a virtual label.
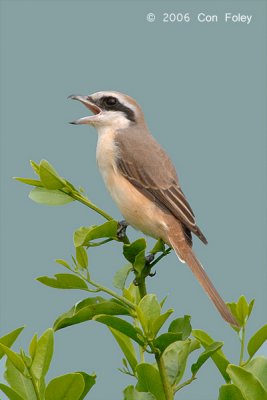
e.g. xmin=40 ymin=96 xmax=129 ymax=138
xmin=115 ymin=132 xmax=207 ymax=244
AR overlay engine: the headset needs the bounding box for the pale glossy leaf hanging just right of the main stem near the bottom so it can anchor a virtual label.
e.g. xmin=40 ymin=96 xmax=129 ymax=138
xmin=162 ymin=339 xmax=192 ymax=385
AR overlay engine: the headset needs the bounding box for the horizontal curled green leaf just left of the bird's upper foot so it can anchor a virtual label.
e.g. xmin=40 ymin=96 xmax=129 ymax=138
xmin=73 ymin=220 xmax=118 ymax=247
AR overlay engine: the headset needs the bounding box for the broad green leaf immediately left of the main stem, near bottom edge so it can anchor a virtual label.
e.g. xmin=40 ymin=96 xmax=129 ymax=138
xmin=136 ymin=363 xmax=166 ymax=400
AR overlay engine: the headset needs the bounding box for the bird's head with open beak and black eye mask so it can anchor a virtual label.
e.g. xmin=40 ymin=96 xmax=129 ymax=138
xmin=69 ymin=91 xmax=143 ymax=129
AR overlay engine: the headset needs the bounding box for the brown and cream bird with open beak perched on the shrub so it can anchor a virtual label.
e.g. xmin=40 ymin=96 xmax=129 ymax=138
xmin=69 ymin=91 xmax=238 ymax=327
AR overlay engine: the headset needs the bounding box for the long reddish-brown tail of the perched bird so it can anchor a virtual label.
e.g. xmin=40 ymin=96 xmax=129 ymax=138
xmin=169 ymin=237 xmax=239 ymax=327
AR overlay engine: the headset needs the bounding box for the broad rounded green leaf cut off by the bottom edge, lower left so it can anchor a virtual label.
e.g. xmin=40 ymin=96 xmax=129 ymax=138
xmin=45 ymin=373 xmax=85 ymax=400
